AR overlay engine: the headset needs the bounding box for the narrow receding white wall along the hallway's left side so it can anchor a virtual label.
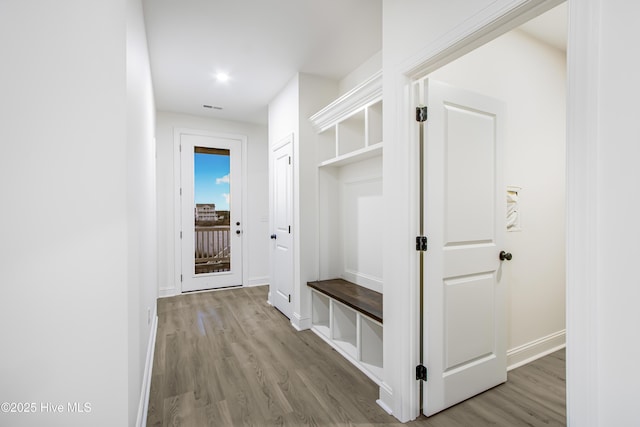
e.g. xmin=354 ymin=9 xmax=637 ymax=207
xmin=127 ymin=0 xmax=158 ymax=425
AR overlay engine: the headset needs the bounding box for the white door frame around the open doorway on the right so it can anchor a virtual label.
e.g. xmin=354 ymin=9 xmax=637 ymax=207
xmin=380 ymin=0 xmax=599 ymax=425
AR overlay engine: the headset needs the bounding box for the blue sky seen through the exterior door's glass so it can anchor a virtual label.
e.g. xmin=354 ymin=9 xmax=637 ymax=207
xmin=193 ymin=153 xmax=230 ymax=211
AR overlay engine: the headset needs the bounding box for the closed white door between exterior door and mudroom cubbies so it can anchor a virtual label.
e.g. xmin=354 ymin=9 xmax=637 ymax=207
xmin=270 ymin=139 xmax=293 ymax=319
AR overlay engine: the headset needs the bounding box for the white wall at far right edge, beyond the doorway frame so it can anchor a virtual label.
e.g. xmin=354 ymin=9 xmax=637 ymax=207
xmin=592 ymin=0 xmax=640 ymax=426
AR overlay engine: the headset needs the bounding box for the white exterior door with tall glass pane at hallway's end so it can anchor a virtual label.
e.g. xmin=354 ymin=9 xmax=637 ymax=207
xmin=180 ymin=134 xmax=242 ymax=292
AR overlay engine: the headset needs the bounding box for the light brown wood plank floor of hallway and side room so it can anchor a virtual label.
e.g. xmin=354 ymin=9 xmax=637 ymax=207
xmin=147 ymin=287 xmax=566 ymax=427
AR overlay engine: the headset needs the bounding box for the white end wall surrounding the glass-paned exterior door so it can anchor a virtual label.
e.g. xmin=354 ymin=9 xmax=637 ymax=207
xmin=156 ymin=111 xmax=269 ymax=296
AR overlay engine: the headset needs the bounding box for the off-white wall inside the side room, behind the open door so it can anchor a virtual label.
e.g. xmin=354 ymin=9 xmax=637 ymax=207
xmin=429 ymin=30 xmax=566 ymax=364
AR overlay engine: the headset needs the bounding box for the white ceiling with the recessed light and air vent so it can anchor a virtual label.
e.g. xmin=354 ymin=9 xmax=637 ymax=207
xmin=143 ymin=0 xmax=566 ymax=124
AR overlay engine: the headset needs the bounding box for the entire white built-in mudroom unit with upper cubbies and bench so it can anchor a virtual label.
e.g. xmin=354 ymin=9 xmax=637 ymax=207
xmin=309 ymin=73 xmax=386 ymax=384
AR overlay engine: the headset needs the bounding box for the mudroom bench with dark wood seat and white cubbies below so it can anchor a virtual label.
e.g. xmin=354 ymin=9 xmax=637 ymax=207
xmin=307 ymin=279 xmax=383 ymax=385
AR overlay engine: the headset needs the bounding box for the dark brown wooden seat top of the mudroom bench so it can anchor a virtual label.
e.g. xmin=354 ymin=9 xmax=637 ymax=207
xmin=307 ymin=279 xmax=382 ymax=323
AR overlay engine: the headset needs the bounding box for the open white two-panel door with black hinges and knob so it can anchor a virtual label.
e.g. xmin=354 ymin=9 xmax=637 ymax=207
xmin=423 ymin=81 xmax=507 ymax=416
